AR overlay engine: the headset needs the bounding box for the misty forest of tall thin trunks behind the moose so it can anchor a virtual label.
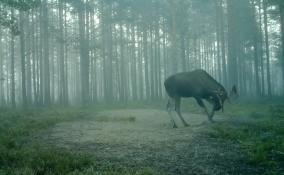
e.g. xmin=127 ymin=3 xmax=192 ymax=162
xmin=0 ymin=0 xmax=284 ymax=107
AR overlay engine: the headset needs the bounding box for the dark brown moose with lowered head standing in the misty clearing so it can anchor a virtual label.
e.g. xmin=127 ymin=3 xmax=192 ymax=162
xmin=164 ymin=69 xmax=237 ymax=128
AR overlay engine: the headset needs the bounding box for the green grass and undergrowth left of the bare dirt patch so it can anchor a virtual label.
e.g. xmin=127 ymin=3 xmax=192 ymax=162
xmin=0 ymin=107 xmax=156 ymax=175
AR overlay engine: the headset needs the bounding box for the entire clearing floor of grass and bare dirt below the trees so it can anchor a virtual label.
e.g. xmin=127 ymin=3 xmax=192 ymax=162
xmin=0 ymin=101 xmax=284 ymax=175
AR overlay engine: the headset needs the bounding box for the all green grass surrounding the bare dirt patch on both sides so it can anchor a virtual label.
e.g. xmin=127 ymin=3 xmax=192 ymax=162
xmin=0 ymin=101 xmax=284 ymax=175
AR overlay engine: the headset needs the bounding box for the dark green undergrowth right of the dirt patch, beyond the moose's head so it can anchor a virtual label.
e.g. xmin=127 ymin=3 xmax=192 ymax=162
xmin=208 ymin=102 xmax=284 ymax=175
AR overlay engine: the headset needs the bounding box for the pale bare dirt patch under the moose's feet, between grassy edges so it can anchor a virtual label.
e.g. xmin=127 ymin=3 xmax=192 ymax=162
xmin=41 ymin=109 xmax=258 ymax=175
